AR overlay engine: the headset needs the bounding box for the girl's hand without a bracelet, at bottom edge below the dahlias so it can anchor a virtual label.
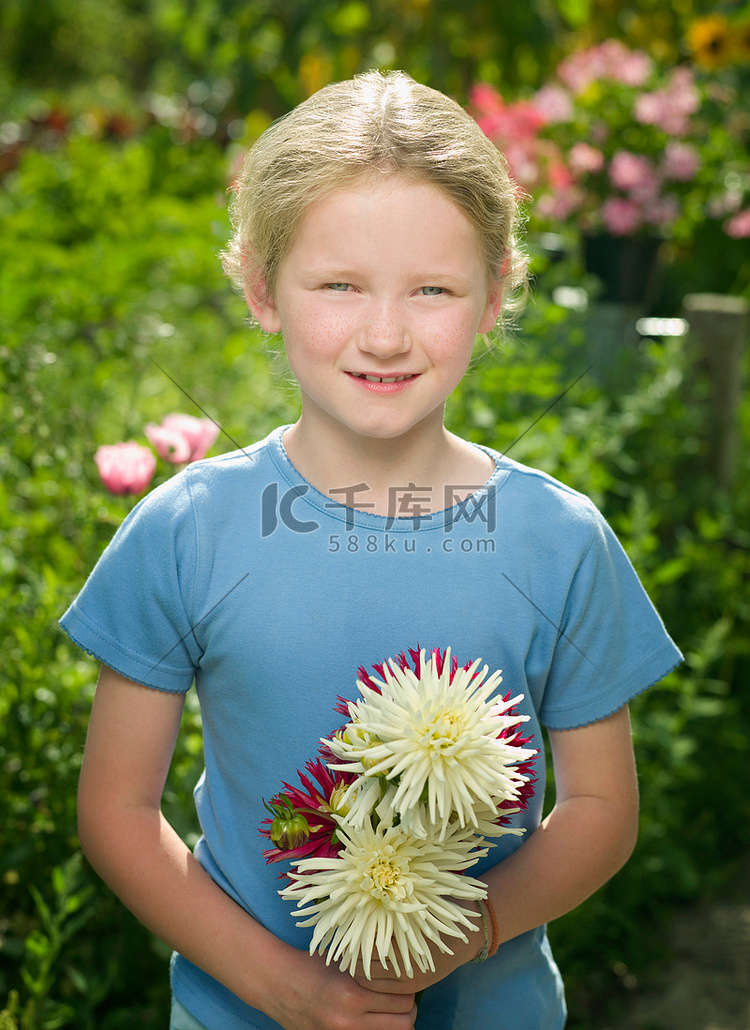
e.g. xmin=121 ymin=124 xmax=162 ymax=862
xmin=268 ymin=953 xmax=416 ymax=1030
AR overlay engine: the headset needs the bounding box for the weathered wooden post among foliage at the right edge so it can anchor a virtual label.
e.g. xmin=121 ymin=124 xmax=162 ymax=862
xmin=683 ymin=294 xmax=750 ymax=490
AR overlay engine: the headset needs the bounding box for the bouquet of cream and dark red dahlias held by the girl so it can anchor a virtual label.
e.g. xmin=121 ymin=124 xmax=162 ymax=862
xmin=261 ymin=648 xmax=536 ymax=977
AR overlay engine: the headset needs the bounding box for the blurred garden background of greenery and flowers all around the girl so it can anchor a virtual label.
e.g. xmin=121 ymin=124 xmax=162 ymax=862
xmin=0 ymin=0 xmax=750 ymax=1030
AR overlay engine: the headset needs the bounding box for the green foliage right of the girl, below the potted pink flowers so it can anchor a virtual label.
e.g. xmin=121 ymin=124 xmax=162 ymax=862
xmin=449 ymin=292 xmax=750 ymax=1030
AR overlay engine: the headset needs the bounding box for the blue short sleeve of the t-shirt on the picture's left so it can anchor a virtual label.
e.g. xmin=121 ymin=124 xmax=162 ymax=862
xmin=60 ymin=475 xmax=201 ymax=692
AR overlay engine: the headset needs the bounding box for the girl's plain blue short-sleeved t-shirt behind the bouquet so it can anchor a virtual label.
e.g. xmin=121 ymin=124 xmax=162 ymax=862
xmin=62 ymin=427 xmax=681 ymax=1030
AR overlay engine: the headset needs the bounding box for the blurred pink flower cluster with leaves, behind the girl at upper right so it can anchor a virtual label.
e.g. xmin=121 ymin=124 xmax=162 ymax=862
xmin=470 ymin=39 xmax=750 ymax=240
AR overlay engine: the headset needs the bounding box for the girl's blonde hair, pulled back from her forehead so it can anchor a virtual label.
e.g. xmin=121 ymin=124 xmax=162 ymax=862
xmin=221 ymin=71 xmax=526 ymax=319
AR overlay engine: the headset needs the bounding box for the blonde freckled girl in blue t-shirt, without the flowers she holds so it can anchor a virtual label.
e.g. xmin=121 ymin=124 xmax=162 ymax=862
xmin=63 ymin=72 xmax=680 ymax=1030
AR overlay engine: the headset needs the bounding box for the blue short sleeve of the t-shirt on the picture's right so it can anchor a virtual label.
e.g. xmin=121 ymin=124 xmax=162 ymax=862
xmin=540 ymin=502 xmax=682 ymax=729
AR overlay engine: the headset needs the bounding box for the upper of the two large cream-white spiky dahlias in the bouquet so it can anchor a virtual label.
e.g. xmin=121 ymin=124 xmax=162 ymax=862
xmin=325 ymin=649 xmax=536 ymax=840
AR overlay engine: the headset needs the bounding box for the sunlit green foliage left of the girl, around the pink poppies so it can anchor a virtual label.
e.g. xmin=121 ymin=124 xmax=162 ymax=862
xmin=0 ymin=128 xmax=295 ymax=1030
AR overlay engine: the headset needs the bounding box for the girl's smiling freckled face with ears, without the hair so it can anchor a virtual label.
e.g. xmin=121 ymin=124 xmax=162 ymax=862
xmin=248 ymin=176 xmax=501 ymax=449
